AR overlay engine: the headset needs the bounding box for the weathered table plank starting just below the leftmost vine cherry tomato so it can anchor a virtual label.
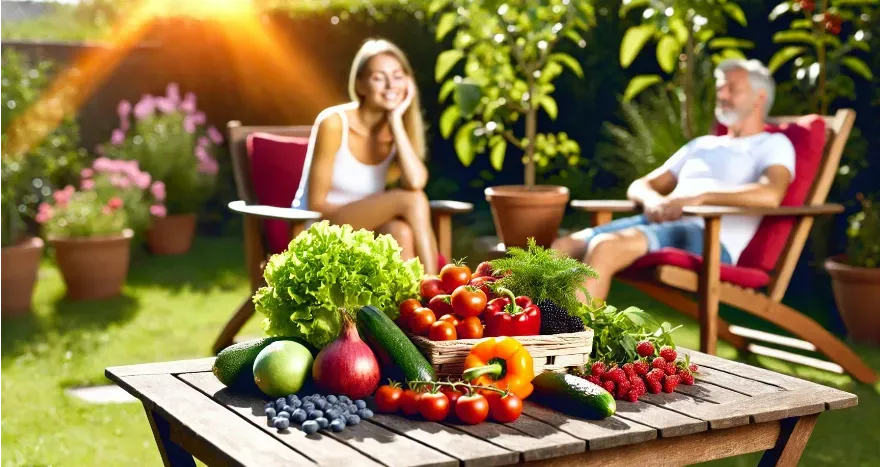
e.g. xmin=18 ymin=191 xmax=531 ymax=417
xmin=370 ymin=414 xmax=519 ymax=467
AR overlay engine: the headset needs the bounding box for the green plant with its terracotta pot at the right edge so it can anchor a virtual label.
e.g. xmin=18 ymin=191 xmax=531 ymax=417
xmin=825 ymin=193 xmax=880 ymax=344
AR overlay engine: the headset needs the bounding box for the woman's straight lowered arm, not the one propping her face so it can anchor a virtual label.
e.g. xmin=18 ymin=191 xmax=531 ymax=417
xmin=308 ymin=113 xmax=343 ymax=215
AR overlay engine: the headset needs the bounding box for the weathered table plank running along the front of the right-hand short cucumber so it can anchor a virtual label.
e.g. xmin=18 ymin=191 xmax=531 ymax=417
xmin=523 ymin=401 xmax=657 ymax=450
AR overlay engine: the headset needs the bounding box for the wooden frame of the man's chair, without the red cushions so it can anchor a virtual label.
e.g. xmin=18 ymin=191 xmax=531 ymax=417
xmin=571 ymin=109 xmax=877 ymax=383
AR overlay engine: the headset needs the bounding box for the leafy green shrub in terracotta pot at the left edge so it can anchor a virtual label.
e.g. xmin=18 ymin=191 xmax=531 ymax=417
xmin=0 ymin=48 xmax=86 ymax=319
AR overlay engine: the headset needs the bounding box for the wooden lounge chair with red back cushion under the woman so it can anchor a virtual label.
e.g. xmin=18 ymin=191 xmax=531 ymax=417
xmin=213 ymin=121 xmax=473 ymax=353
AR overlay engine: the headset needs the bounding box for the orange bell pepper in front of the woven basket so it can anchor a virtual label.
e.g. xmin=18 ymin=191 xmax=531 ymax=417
xmin=462 ymin=336 xmax=535 ymax=399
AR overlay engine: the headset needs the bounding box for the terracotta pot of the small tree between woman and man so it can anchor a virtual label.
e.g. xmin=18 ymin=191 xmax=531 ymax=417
xmin=485 ymin=185 xmax=569 ymax=248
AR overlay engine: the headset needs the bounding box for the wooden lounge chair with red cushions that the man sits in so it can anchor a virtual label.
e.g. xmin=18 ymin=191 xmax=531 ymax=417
xmin=571 ymin=109 xmax=877 ymax=383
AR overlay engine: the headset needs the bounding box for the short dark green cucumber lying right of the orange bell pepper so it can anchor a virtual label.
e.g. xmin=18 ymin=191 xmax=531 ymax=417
xmin=530 ymin=371 xmax=617 ymax=420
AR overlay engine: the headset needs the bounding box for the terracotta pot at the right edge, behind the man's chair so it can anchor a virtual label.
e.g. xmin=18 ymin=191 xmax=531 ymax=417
xmin=825 ymin=255 xmax=880 ymax=344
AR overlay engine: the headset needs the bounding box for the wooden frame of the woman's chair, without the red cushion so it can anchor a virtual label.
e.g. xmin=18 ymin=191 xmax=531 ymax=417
xmin=212 ymin=120 xmax=474 ymax=354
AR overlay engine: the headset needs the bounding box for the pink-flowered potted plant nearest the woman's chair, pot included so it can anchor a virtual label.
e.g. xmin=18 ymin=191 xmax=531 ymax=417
xmin=100 ymin=83 xmax=223 ymax=255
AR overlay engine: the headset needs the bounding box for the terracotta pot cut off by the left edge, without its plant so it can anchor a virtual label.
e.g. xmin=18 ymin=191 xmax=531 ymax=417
xmin=0 ymin=237 xmax=43 ymax=318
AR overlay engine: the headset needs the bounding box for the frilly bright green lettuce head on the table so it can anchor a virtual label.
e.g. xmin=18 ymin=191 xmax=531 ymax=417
xmin=253 ymin=221 xmax=424 ymax=349
